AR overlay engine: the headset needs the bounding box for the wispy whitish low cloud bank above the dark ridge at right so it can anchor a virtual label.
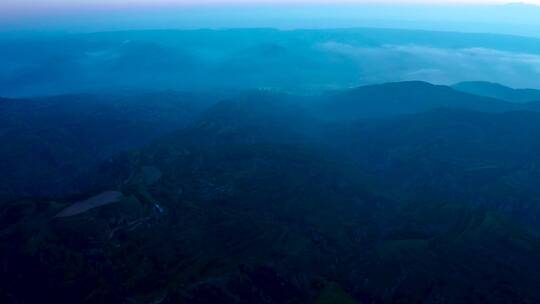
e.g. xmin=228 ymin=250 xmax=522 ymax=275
xmin=320 ymin=41 xmax=540 ymax=87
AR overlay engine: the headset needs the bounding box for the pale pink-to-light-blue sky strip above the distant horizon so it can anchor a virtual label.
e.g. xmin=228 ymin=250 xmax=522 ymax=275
xmin=0 ymin=0 xmax=540 ymax=37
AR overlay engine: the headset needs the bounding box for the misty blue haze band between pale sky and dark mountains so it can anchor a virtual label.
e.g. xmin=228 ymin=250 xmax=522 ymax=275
xmin=0 ymin=29 xmax=540 ymax=97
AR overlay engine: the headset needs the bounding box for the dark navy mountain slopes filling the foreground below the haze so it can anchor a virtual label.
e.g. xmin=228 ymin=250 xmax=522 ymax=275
xmin=0 ymin=79 xmax=540 ymax=304
